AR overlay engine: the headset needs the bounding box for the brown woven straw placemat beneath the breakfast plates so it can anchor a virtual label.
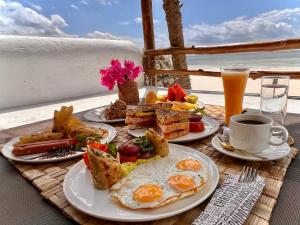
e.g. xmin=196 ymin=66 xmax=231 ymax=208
xmin=0 ymin=105 xmax=298 ymax=225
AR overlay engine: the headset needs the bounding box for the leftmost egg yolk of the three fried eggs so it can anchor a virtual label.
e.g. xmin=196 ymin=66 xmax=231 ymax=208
xmin=133 ymin=184 xmax=163 ymax=203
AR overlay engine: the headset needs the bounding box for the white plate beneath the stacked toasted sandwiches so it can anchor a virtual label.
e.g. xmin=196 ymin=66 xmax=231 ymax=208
xmin=127 ymin=116 xmax=219 ymax=143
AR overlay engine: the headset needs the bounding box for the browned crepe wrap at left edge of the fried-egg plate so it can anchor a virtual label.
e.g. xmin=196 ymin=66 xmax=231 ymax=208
xmin=87 ymin=148 xmax=122 ymax=190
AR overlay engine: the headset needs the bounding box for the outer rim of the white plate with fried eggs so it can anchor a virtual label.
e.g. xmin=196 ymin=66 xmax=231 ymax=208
xmin=63 ymin=143 xmax=220 ymax=222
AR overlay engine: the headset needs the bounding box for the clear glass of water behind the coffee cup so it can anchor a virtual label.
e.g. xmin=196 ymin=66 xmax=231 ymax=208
xmin=260 ymin=76 xmax=290 ymax=125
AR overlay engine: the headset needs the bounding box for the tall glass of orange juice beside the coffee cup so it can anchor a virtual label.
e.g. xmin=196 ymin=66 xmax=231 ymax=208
xmin=221 ymin=67 xmax=250 ymax=126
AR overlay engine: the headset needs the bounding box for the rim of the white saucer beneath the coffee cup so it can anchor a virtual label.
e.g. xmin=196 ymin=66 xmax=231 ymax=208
xmin=211 ymin=134 xmax=291 ymax=162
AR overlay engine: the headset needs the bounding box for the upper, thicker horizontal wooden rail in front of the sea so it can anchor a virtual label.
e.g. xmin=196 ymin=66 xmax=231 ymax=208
xmin=144 ymin=39 xmax=300 ymax=56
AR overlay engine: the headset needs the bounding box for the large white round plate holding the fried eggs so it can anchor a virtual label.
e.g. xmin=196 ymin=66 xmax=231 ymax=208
xmin=63 ymin=144 xmax=219 ymax=222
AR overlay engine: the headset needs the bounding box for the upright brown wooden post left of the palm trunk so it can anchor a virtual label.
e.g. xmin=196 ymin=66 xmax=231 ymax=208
xmin=141 ymin=0 xmax=156 ymax=86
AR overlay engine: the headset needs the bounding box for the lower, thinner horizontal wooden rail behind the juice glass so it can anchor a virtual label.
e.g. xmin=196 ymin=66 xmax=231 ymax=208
xmin=142 ymin=69 xmax=300 ymax=80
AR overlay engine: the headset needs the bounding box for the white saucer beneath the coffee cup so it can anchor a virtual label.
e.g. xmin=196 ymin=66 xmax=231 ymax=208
xmin=211 ymin=134 xmax=291 ymax=161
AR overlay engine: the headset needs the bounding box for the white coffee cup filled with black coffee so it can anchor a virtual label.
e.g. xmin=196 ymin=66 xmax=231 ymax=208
xmin=229 ymin=114 xmax=288 ymax=153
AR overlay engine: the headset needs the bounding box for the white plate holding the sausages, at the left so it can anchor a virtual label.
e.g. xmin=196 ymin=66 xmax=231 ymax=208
xmin=2 ymin=122 xmax=117 ymax=163
